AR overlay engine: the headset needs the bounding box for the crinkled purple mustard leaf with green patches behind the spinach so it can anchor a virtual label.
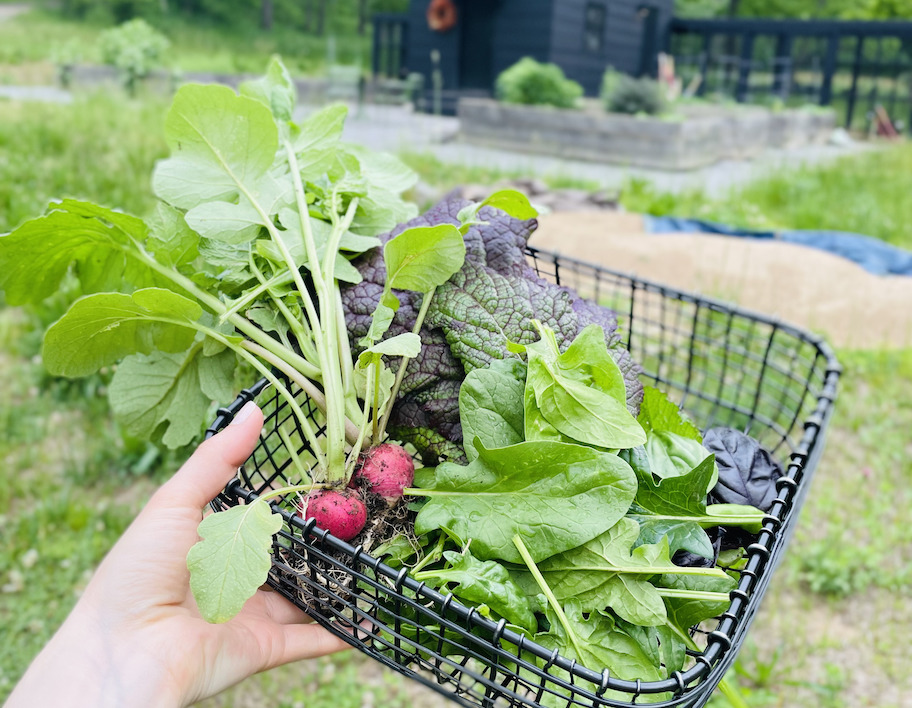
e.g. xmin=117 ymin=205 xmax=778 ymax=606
xmin=342 ymin=197 xmax=643 ymax=459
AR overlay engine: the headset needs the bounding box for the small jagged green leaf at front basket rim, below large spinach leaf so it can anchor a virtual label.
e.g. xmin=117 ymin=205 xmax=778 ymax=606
xmin=420 ymin=550 xmax=538 ymax=632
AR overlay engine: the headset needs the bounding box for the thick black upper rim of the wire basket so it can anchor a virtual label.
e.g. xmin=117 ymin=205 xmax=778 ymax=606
xmin=206 ymin=253 xmax=842 ymax=706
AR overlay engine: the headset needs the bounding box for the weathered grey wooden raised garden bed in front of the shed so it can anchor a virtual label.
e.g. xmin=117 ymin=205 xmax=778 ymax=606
xmin=458 ymin=98 xmax=836 ymax=170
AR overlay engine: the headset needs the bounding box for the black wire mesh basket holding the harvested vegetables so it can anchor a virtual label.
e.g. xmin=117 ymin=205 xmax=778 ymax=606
xmin=207 ymin=249 xmax=840 ymax=708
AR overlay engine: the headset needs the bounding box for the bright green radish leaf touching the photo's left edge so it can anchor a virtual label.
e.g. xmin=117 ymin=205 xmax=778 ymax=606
xmin=0 ymin=200 xmax=164 ymax=305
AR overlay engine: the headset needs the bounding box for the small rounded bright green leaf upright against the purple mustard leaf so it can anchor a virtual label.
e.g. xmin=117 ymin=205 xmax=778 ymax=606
xmin=383 ymin=224 xmax=465 ymax=293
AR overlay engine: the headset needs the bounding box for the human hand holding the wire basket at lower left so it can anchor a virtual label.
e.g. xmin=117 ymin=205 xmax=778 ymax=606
xmin=6 ymin=403 xmax=348 ymax=708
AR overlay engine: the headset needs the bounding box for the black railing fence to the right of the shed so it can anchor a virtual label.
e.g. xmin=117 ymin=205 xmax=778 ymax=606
xmin=668 ymin=18 xmax=912 ymax=131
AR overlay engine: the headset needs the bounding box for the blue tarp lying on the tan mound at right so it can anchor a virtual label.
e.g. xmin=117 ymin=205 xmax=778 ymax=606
xmin=643 ymin=216 xmax=912 ymax=276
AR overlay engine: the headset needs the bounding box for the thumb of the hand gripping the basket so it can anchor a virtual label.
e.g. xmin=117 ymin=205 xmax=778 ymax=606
xmin=153 ymin=401 xmax=263 ymax=509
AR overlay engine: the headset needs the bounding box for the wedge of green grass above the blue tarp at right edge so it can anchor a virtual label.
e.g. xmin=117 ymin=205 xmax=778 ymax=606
xmin=621 ymin=143 xmax=912 ymax=248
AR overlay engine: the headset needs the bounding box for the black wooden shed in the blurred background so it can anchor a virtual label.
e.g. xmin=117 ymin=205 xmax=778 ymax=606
xmin=374 ymin=0 xmax=674 ymax=101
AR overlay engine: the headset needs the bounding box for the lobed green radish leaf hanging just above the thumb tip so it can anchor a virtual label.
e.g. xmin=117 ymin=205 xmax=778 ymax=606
xmin=108 ymin=342 xmax=237 ymax=448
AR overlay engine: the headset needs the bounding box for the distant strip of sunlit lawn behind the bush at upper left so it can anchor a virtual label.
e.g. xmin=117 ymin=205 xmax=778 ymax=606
xmin=0 ymin=10 xmax=370 ymax=81
